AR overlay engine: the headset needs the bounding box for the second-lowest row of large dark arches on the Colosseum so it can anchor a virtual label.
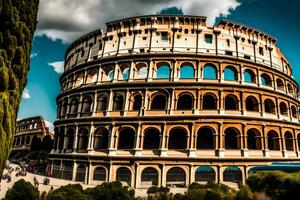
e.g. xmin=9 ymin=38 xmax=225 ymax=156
xmin=55 ymin=126 xmax=300 ymax=151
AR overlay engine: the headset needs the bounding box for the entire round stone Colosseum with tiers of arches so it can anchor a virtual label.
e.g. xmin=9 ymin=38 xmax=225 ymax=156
xmin=51 ymin=15 xmax=300 ymax=190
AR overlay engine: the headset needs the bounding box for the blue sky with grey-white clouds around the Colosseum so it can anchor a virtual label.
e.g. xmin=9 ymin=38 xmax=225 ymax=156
xmin=18 ymin=0 xmax=300 ymax=131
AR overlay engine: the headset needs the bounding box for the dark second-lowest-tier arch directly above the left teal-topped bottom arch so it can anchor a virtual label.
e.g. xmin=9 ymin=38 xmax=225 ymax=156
xmin=197 ymin=127 xmax=215 ymax=149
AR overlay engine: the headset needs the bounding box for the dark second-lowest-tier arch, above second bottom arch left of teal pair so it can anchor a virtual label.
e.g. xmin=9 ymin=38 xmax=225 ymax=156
xmin=144 ymin=128 xmax=160 ymax=149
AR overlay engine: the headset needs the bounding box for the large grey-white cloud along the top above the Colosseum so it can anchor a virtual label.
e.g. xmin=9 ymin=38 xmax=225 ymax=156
xmin=36 ymin=0 xmax=241 ymax=42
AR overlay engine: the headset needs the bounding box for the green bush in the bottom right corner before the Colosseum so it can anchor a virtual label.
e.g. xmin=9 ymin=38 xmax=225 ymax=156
xmin=246 ymin=171 xmax=300 ymax=200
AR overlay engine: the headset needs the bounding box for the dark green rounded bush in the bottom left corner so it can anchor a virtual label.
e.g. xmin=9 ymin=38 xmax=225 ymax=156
xmin=5 ymin=179 xmax=40 ymax=200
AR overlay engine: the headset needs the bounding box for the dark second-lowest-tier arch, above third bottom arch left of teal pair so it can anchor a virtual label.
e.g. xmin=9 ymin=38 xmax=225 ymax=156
xmin=118 ymin=128 xmax=135 ymax=149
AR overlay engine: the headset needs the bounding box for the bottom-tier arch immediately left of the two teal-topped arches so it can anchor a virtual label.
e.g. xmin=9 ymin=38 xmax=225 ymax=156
xmin=167 ymin=167 xmax=186 ymax=187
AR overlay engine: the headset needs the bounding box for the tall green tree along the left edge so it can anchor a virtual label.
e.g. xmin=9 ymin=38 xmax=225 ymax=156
xmin=0 ymin=0 xmax=39 ymax=175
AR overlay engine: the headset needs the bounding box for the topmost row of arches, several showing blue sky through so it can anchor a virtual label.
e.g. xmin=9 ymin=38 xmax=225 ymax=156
xmin=62 ymin=62 xmax=298 ymax=96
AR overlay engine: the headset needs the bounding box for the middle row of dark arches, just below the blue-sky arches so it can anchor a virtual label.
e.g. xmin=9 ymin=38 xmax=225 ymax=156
xmin=59 ymin=92 xmax=298 ymax=118
